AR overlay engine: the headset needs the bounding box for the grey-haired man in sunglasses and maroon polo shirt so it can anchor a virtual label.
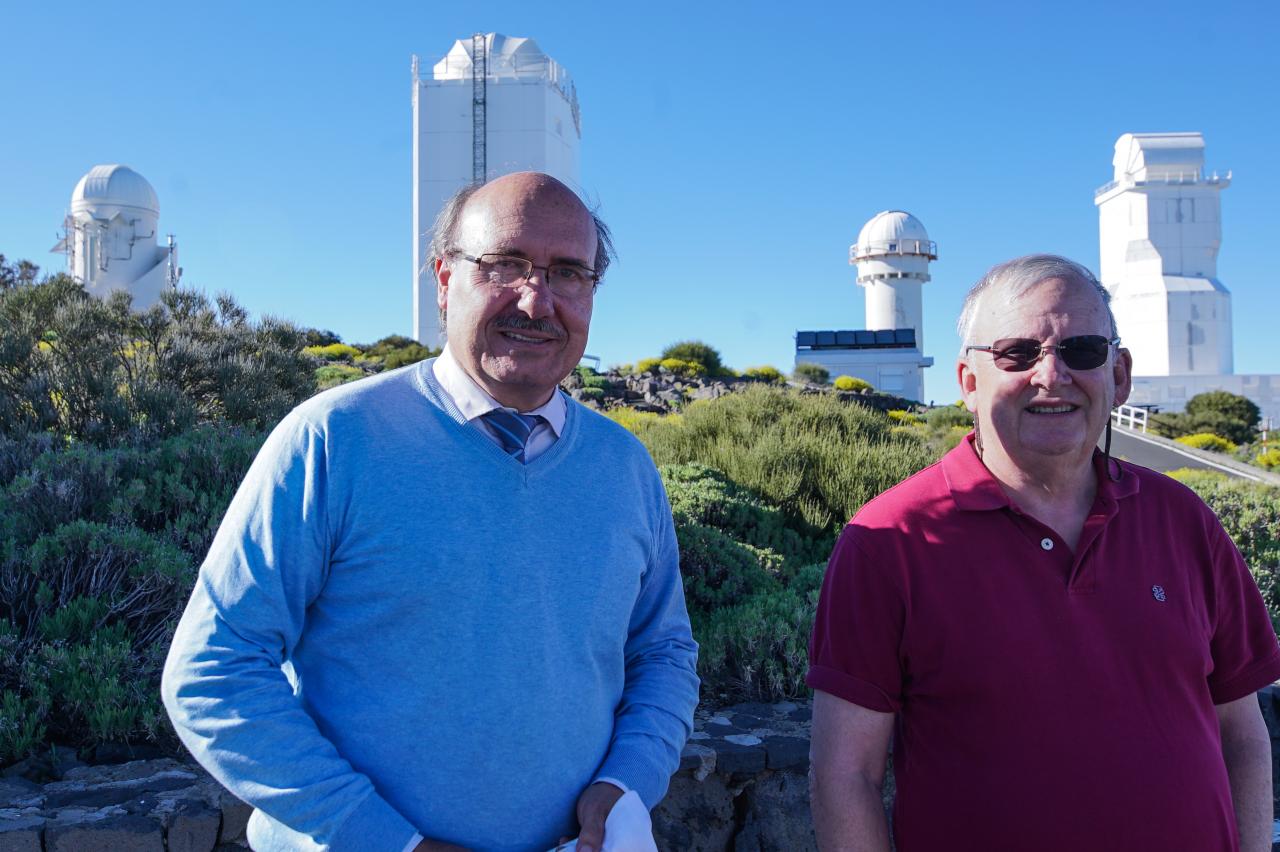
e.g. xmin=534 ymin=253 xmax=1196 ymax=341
xmin=808 ymin=256 xmax=1280 ymax=852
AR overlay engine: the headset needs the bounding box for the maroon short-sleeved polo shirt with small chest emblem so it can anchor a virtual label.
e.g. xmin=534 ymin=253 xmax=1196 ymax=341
xmin=808 ymin=435 xmax=1280 ymax=852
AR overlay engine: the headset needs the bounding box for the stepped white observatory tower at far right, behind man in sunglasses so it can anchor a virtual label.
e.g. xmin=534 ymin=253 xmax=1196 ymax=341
xmin=1093 ymin=133 xmax=1280 ymax=420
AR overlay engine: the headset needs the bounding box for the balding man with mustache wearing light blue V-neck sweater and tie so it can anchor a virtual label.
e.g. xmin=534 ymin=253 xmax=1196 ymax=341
xmin=163 ymin=173 xmax=698 ymax=852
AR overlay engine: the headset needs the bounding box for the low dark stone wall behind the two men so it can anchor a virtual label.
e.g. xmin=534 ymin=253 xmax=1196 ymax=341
xmin=0 ymin=687 xmax=1280 ymax=852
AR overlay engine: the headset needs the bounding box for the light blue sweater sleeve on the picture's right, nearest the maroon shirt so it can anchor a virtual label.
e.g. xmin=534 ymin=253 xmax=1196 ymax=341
xmin=596 ymin=473 xmax=698 ymax=809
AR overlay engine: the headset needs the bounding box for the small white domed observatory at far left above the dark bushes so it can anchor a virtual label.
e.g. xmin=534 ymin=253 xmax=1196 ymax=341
xmin=52 ymin=165 xmax=182 ymax=310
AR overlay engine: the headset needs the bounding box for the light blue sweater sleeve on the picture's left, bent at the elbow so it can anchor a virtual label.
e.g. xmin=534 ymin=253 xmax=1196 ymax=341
xmin=161 ymin=413 xmax=416 ymax=852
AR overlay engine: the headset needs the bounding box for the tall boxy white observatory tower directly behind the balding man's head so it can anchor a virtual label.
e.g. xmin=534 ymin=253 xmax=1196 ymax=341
xmin=412 ymin=32 xmax=582 ymax=347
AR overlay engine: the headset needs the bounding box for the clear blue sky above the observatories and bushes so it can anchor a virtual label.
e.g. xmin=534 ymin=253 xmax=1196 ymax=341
xmin=0 ymin=0 xmax=1280 ymax=402
